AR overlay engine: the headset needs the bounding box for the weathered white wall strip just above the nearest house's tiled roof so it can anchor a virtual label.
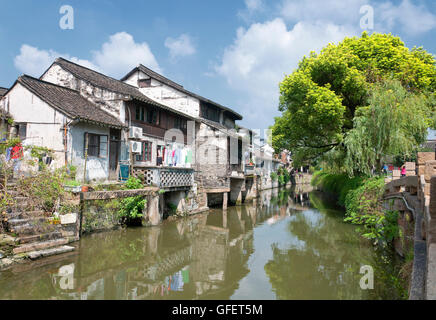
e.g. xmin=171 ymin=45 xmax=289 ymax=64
xmin=42 ymin=65 xmax=126 ymax=123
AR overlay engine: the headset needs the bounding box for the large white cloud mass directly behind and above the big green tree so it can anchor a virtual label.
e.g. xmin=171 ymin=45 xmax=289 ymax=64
xmin=215 ymin=0 xmax=436 ymax=130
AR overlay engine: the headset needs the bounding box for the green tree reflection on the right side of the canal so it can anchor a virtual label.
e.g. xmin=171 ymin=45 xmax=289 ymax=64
xmin=265 ymin=193 xmax=406 ymax=299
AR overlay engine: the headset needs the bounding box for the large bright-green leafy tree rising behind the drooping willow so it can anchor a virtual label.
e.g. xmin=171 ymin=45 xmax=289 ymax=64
xmin=272 ymin=33 xmax=436 ymax=169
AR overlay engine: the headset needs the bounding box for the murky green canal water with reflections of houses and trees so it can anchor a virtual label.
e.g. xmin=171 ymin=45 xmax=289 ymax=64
xmin=0 ymin=190 xmax=401 ymax=300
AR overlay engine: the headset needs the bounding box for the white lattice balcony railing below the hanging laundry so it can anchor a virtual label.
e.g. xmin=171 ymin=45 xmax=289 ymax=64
xmin=134 ymin=167 xmax=194 ymax=189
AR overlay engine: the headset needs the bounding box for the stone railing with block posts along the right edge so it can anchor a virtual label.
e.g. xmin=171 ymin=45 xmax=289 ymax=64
xmin=384 ymin=152 xmax=436 ymax=300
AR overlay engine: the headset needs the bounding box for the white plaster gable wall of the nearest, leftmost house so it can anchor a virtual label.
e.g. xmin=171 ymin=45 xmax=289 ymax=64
xmin=6 ymin=83 xmax=68 ymax=167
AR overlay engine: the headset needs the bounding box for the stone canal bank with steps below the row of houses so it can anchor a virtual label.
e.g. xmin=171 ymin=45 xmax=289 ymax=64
xmin=0 ymin=172 xmax=310 ymax=269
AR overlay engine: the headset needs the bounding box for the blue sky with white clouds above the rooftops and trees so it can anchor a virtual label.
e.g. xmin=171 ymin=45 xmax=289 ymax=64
xmin=0 ymin=0 xmax=436 ymax=129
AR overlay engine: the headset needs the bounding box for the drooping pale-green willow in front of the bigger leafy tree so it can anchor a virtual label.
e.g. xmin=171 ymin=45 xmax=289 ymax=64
xmin=344 ymin=80 xmax=431 ymax=174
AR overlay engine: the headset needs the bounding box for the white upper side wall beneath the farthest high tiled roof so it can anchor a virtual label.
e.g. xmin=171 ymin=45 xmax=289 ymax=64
xmin=124 ymin=71 xmax=200 ymax=117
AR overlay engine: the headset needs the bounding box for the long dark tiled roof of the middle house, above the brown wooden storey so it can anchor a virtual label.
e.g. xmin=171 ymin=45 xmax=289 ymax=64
xmin=48 ymin=58 xmax=193 ymax=119
